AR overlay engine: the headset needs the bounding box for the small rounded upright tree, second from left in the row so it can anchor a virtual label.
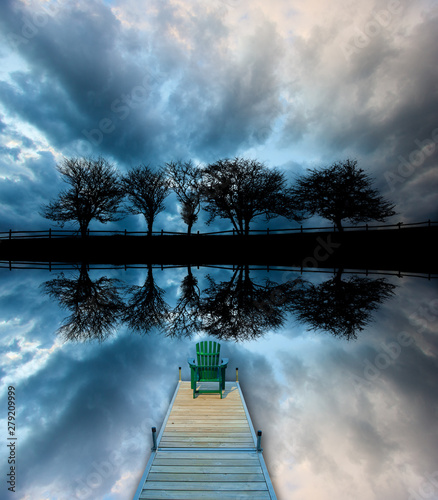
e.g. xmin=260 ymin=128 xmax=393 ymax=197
xmin=122 ymin=165 xmax=169 ymax=236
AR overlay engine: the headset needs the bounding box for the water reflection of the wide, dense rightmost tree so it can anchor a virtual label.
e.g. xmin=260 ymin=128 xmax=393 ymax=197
xmin=288 ymin=271 xmax=395 ymax=339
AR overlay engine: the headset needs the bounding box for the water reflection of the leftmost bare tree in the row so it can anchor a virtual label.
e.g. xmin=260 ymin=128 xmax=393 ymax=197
xmin=43 ymin=264 xmax=124 ymax=341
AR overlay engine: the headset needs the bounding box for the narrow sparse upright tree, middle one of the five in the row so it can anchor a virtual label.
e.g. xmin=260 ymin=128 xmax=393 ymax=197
xmin=166 ymin=161 xmax=202 ymax=234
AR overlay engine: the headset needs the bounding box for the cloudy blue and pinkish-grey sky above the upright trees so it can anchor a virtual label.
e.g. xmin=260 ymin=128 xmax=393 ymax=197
xmin=0 ymin=0 xmax=438 ymax=236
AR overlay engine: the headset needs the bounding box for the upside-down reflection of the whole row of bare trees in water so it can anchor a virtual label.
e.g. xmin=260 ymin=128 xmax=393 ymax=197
xmin=43 ymin=264 xmax=395 ymax=341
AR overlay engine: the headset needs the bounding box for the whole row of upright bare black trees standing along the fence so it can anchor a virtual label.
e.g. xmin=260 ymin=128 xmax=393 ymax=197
xmin=41 ymin=157 xmax=395 ymax=236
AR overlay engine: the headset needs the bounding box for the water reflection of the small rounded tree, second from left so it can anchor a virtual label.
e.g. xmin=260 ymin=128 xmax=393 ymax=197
xmin=123 ymin=264 xmax=169 ymax=333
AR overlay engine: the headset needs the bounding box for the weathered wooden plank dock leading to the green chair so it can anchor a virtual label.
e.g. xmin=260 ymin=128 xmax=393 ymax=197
xmin=134 ymin=382 xmax=276 ymax=500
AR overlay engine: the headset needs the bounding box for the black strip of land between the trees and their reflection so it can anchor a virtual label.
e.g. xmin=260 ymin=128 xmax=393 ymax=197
xmin=0 ymin=227 xmax=438 ymax=274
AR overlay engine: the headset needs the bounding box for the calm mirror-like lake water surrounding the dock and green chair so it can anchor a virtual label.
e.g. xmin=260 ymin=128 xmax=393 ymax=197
xmin=0 ymin=267 xmax=438 ymax=500
